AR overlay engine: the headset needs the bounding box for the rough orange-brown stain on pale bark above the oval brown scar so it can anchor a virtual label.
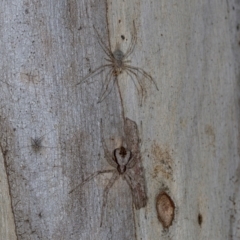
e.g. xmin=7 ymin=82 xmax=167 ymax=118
xmin=152 ymin=142 xmax=173 ymax=180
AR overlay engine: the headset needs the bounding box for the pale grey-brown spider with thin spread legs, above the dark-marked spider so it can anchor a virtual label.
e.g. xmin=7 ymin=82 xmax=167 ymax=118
xmin=75 ymin=21 xmax=159 ymax=103
